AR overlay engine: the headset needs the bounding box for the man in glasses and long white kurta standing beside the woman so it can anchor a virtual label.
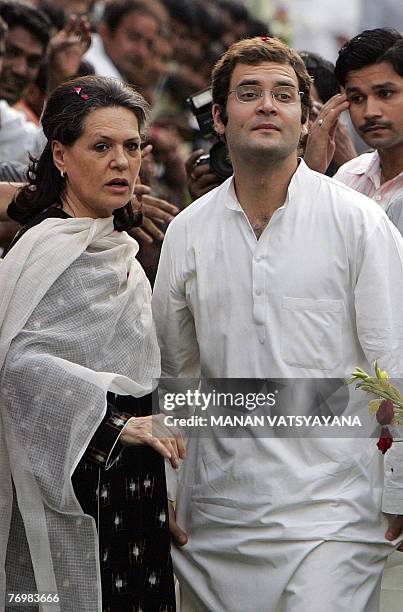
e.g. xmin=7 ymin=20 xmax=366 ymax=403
xmin=153 ymin=39 xmax=403 ymax=612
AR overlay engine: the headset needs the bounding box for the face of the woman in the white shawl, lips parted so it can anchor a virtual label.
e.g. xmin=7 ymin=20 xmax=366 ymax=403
xmin=52 ymin=102 xmax=141 ymax=219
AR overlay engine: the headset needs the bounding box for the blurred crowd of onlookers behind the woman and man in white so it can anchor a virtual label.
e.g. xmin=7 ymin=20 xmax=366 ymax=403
xmin=0 ymin=0 xmax=403 ymax=282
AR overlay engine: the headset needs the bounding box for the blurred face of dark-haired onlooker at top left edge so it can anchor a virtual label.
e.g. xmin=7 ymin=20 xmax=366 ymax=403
xmin=0 ymin=26 xmax=45 ymax=104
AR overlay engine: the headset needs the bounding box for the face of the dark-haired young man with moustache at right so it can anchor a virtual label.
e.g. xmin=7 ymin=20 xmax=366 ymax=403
xmin=345 ymin=62 xmax=403 ymax=151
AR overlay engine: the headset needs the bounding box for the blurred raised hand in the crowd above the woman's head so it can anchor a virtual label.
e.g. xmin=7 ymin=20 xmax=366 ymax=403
xmin=48 ymin=15 xmax=91 ymax=91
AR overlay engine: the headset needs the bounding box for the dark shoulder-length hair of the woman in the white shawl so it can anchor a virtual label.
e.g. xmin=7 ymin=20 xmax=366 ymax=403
xmin=7 ymin=76 xmax=149 ymax=231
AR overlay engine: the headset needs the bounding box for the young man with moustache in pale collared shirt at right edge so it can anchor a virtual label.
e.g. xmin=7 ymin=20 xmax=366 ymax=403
xmin=304 ymin=28 xmax=403 ymax=233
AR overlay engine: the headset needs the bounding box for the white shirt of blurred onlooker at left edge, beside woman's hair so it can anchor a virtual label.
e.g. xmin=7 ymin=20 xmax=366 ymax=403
xmin=0 ymin=100 xmax=46 ymax=164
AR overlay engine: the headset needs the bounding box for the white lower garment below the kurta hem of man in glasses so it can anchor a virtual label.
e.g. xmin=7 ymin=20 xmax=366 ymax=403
xmin=181 ymin=540 xmax=390 ymax=612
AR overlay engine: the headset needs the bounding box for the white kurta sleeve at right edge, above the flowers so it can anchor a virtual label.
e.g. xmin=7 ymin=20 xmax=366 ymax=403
xmin=355 ymin=217 xmax=403 ymax=514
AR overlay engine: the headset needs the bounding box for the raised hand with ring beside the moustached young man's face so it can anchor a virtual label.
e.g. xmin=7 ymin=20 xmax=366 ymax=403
xmin=304 ymin=93 xmax=349 ymax=174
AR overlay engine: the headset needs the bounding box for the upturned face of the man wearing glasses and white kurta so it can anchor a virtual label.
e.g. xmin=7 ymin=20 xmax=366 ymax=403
xmin=213 ymin=62 xmax=303 ymax=165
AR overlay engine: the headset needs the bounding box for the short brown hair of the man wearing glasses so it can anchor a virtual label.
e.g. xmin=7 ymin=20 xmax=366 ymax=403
xmin=212 ymin=36 xmax=311 ymax=124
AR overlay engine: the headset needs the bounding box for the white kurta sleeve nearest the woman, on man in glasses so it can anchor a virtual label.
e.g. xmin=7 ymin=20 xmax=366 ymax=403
xmin=152 ymin=222 xmax=200 ymax=501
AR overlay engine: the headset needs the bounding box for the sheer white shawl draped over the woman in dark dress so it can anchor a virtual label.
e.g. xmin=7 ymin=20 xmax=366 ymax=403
xmin=0 ymin=218 xmax=160 ymax=612
